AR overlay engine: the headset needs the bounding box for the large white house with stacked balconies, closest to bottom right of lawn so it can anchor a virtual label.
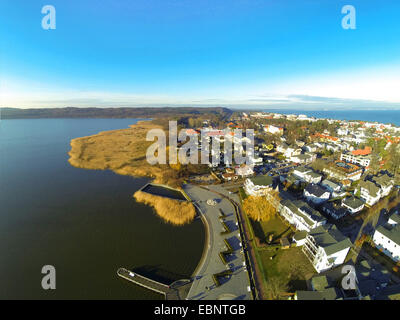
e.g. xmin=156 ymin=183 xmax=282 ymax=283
xmin=302 ymin=224 xmax=352 ymax=273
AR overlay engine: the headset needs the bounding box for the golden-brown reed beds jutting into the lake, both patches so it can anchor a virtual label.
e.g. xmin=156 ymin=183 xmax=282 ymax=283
xmin=69 ymin=121 xmax=203 ymax=225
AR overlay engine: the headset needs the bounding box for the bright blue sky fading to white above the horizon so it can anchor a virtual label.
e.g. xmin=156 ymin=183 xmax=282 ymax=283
xmin=0 ymin=0 xmax=400 ymax=108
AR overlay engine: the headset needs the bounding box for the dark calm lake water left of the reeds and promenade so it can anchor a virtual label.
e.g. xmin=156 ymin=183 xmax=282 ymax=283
xmin=0 ymin=119 xmax=204 ymax=299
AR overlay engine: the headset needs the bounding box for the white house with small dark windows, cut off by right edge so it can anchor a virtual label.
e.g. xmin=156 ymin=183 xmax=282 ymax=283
xmin=373 ymin=224 xmax=400 ymax=262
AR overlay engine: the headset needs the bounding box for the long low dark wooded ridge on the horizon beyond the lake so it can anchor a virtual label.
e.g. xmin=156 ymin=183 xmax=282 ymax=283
xmin=1 ymin=107 xmax=232 ymax=119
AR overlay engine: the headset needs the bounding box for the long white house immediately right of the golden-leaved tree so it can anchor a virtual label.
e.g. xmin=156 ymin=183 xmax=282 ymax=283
xmin=278 ymin=199 xmax=326 ymax=231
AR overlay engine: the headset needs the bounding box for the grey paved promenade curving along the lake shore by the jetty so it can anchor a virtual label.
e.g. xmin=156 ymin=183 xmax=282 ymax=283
xmin=184 ymin=184 xmax=251 ymax=300
